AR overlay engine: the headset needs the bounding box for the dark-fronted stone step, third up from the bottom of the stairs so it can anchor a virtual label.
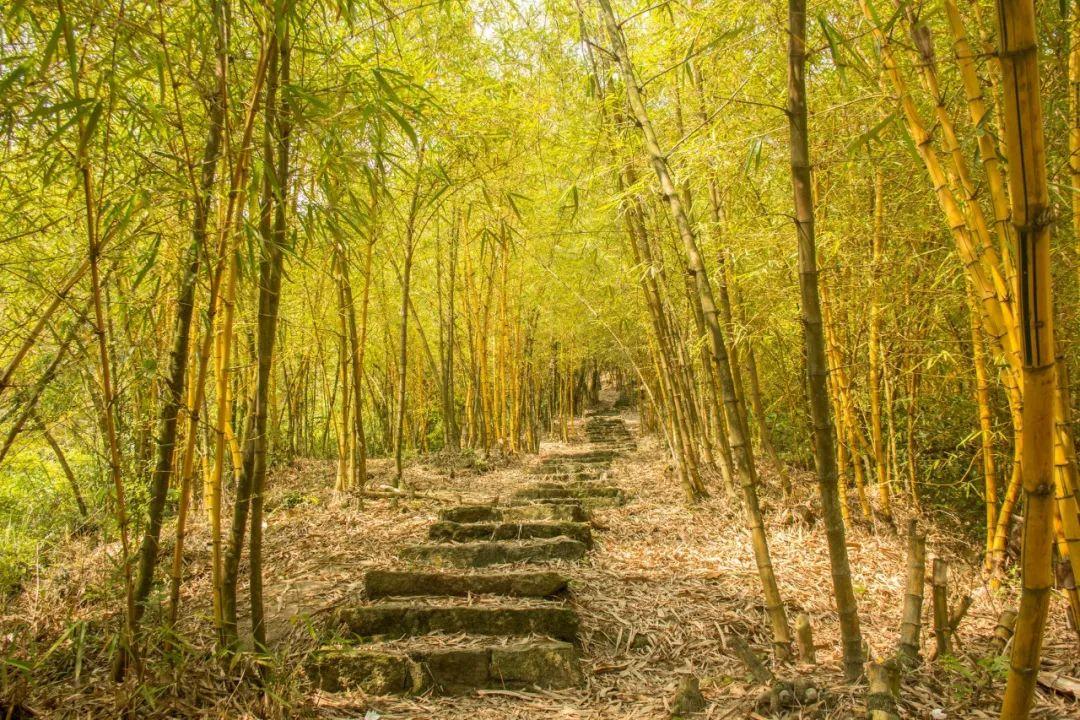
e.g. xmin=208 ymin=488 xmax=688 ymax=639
xmin=364 ymin=570 xmax=568 ymax=599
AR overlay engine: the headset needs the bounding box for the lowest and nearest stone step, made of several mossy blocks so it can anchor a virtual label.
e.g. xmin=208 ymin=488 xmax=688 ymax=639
xmin=305 ymin=640 xmax=583 ymax=695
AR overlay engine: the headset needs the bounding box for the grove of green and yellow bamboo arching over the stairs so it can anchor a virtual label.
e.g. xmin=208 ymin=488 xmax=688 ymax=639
xmin=0 ymin=0 xmax=1080 ymax=718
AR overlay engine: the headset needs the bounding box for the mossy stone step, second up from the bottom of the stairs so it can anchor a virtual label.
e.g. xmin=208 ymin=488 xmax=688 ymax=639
xmin=337 ymin=602 xmax=578 ymax=641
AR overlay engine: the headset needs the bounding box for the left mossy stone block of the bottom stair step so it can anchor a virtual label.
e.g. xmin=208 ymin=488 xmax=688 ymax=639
xmin=305 ymin=647 xmax=423 ymax=695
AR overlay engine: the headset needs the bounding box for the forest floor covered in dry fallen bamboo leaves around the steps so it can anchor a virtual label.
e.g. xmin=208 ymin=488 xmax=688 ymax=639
xmin=0 ymin=415 xmax=1080 ymax=720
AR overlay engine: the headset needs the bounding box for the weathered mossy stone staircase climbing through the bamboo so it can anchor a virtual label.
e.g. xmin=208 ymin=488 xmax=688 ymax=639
xmin=306 ymin=413 xmax=636 ymax=695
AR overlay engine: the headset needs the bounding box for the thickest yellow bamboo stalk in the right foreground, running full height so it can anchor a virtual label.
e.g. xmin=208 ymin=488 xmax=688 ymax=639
xmin=998 ymin=0 xmax=1056 ymax=720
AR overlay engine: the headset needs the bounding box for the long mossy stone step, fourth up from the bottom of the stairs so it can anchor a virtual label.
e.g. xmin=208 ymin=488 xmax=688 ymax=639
xmin=400 ymin=538 xmax=586 ymax=568
